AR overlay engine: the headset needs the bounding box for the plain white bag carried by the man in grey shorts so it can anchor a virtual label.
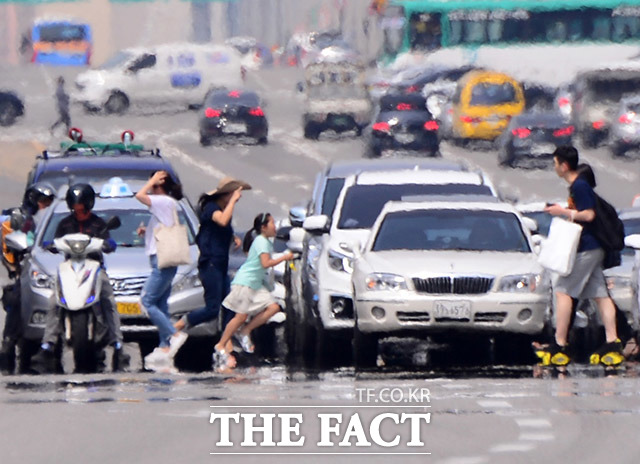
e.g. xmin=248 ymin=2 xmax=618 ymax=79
xmin=538 ymin=217 xmax=582 ymax=276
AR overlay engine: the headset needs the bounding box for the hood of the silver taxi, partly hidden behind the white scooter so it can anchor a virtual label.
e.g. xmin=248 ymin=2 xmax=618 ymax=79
xmin=32 ymin=245 xmax=198 ymax=278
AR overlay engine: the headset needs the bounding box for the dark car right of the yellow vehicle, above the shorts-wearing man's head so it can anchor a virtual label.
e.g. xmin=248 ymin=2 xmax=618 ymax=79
xmin=497 ymin=111 xmax=574 ymax=168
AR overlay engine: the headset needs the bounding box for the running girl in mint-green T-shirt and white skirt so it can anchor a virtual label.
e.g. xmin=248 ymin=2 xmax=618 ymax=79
xmin=213 ymin=213 xmax=293 ymax=370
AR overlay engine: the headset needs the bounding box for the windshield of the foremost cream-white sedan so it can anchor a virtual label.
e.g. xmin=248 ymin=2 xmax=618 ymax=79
xmin=372 ymin=209 xmax=531 ymax=253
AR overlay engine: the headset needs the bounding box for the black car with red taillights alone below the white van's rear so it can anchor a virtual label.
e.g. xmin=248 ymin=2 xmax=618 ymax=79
xmin=199 ymin=90 xmax=269 ymax=146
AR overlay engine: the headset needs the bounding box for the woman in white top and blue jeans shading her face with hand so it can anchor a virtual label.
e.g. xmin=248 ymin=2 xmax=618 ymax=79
xmin=136 ymin=171 xmax=187 ymax=372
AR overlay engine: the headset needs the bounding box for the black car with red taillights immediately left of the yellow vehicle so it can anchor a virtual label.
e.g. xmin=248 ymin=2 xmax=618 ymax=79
xmin=366 ymin=94 xmax=440 ymax=158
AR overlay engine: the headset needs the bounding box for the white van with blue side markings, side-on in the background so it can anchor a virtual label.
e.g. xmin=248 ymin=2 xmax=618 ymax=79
xmin=72 ymin=43 xmax=244 ymax=114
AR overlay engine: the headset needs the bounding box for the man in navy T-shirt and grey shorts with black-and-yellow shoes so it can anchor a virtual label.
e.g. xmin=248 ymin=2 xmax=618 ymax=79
xmin=545 ymin=146 xmax=624 ymax=365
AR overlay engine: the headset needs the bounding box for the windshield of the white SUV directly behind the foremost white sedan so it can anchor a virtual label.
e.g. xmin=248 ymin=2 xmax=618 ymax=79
xmin=338 ymin=184 xmax=491 ymax=229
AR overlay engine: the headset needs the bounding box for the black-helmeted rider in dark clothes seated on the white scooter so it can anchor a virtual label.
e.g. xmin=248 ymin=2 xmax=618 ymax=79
xmin=32 ymin=184 xmax=130 ymax=373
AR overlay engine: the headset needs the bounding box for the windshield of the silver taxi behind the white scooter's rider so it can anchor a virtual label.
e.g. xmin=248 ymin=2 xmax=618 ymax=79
xmin=40 ymin=209 xmax=195 ymax=248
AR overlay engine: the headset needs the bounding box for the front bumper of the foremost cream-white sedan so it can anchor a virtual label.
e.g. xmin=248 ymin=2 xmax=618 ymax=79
xmin=355 ymin=292 xmax=550 ymax=335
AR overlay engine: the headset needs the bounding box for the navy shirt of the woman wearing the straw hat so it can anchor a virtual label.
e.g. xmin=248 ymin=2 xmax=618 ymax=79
xmin=196 ymin=201 xmax=233 ymax=263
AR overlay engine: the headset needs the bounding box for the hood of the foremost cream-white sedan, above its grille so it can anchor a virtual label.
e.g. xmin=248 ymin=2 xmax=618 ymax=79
xmin=356 ymin=250 xmax=543 ymax=278
